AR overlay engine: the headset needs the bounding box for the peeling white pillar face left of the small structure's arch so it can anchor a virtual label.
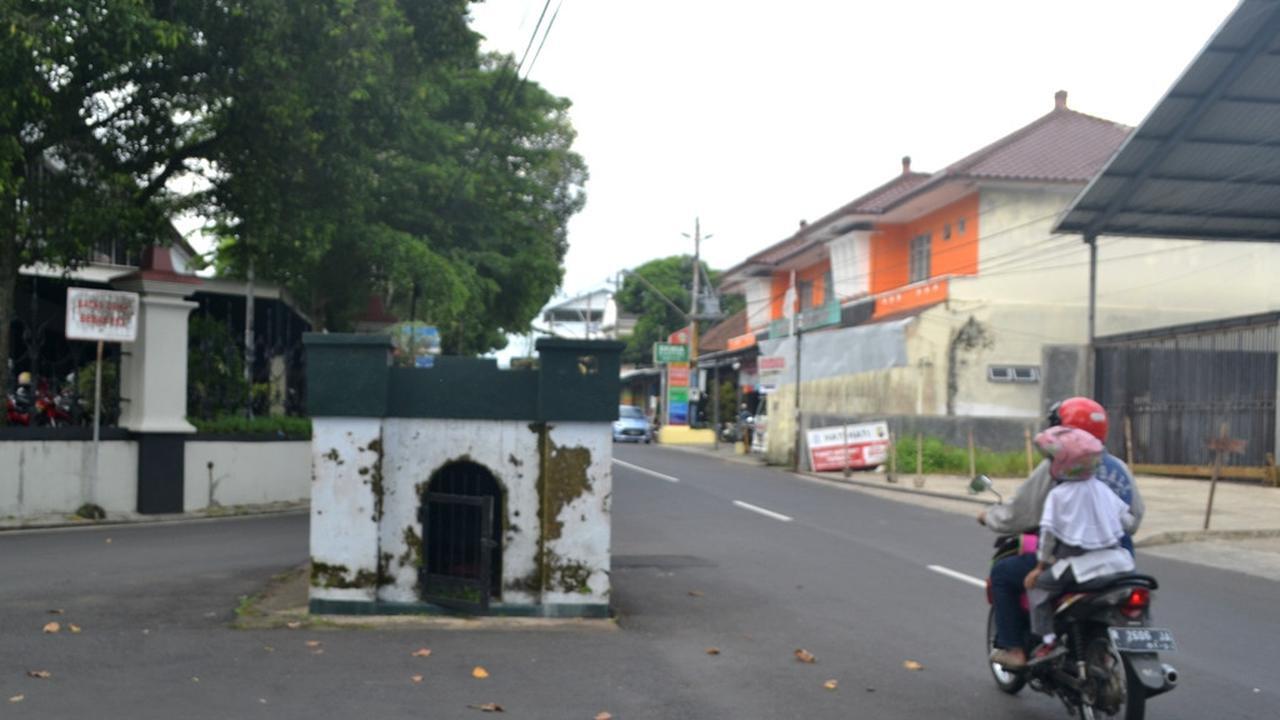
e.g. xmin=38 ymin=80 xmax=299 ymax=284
xmin=311 ymin=418 xmax=381 ymax=602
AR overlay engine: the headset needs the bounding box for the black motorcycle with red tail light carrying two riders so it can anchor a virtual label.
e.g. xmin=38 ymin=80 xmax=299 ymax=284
xmin=972 ymin=477 xmax=1178 ymax=720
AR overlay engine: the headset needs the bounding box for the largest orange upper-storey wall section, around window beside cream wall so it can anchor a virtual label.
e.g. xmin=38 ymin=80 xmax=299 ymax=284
xmin=870 ymin=192 xmax=978 ymax=293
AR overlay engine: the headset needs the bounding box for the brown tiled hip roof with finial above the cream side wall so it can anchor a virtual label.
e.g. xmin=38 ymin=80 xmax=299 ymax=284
xmin=940 ymin=108 xmax=1133 ymax=182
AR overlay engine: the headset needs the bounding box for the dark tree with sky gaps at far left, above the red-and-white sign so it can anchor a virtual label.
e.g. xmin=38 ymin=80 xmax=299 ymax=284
xmin=0 ymin=0 xmax=205 ymax=387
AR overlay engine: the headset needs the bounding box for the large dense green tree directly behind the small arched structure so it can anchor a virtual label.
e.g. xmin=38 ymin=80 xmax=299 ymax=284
xmin=203 ymin=0 xmax=586 ymax=354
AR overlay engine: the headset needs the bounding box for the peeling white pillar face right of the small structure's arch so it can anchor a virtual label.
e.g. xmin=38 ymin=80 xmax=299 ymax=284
xmin=543 ymin=423 xmax=613 ymax=605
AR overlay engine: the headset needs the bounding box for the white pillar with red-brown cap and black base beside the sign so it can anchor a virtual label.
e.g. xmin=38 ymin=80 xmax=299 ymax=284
xmin=113 ymin=247 xmax=200 ymax=514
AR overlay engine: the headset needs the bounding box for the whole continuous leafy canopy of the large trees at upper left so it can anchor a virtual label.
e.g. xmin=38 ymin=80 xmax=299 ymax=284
xmin=0 ymin=0 xmax=586 ymax=389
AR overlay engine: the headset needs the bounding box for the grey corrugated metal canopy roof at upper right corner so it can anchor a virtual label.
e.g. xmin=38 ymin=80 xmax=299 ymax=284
xmin=1057 ymin=0 xmax=1280 ymax=241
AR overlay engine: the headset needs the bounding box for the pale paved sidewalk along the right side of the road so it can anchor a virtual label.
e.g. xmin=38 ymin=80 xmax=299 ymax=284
xmin=664 ymin=446 xmax=1280 ymax=547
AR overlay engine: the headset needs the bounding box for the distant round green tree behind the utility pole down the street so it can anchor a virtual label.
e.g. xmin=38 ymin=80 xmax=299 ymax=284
xmin=617 ymin=255 xmax=745 ymax=364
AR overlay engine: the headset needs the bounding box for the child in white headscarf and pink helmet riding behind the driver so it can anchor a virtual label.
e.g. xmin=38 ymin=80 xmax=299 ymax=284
xmin=1024 ymin=427 xmax=1134 ymax=662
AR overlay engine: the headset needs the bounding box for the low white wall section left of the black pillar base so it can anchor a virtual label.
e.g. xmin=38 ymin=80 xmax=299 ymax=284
xmin=0 ymin=441 xmax=138 ymax=518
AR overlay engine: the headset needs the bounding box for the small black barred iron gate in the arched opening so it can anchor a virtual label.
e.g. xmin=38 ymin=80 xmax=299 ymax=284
xmin=419 ymin=492 xmax=497 ymax=612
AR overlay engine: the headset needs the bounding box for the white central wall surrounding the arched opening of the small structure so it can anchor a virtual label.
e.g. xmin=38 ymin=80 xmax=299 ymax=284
xmin=378 ymin=419 xmax=542 ymax=605
